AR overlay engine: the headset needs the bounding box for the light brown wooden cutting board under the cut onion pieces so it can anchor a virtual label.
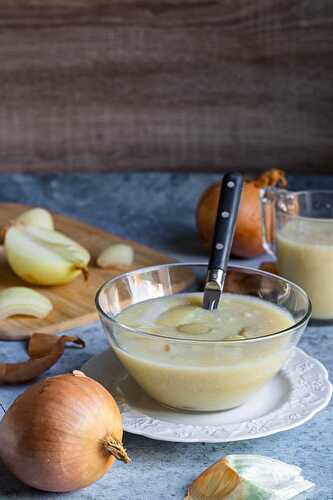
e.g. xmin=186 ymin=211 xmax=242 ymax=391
xmin=0 ymin=203 xmax=174 ymax=339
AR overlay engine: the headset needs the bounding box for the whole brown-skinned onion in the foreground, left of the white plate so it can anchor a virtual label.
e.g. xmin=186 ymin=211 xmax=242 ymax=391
xmin=0 ymin=372 xmax=129 ymax=492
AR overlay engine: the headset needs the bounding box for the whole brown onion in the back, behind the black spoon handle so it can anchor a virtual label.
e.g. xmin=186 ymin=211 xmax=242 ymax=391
xmin=196 ymin=169 xmax=287 ymax=257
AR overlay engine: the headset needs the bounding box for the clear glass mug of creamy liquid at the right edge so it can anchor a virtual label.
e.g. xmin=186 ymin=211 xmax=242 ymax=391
xmin=261 ymin=188 xmax=333 ymax=320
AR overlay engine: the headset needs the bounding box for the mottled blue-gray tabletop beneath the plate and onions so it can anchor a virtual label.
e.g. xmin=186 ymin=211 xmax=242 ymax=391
xmin=0 ymin=173 xmax=333 ymax=500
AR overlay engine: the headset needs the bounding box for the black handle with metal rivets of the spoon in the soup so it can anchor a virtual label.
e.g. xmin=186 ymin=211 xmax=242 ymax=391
xmin=208 ymin=173 xmax=243 ymax=271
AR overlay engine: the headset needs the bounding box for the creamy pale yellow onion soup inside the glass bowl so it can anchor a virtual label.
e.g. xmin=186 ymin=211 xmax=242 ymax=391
xmin=113 ymin=293 xmax=294 ymax=411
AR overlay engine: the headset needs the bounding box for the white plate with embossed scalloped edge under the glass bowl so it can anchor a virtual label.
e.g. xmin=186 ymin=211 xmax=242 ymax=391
xmin=82 ymin=348 xmax=332 ymax=443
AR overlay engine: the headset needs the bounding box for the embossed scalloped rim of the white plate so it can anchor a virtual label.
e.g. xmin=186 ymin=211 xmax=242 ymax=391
xmin=81 ymin=347 xmax=333 ymax=443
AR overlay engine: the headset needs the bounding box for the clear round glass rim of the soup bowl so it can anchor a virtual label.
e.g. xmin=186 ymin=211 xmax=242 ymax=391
xmin=95 ymin=262 xmax=312 ymax=345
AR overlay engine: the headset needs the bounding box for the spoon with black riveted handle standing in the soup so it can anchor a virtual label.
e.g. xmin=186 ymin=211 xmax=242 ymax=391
xmin=203 ymin=172 xmax=243 ymax=311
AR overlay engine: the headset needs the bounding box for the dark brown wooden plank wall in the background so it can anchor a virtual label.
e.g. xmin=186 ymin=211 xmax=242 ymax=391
xmin=0 ymin=0 xmax=333 ymax=173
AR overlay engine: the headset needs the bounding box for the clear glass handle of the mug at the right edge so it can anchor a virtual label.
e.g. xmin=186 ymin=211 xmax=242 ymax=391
xmin=260 ymin=188 xmax=277 ymax=257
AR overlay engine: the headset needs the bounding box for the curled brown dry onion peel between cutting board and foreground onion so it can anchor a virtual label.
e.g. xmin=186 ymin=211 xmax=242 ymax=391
xmin=0 ymin=333 xmax=85 ymax=384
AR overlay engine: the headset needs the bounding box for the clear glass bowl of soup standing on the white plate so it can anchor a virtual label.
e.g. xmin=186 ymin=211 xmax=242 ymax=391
xmin=96 ymin=264 xmax=311 ymax=411
